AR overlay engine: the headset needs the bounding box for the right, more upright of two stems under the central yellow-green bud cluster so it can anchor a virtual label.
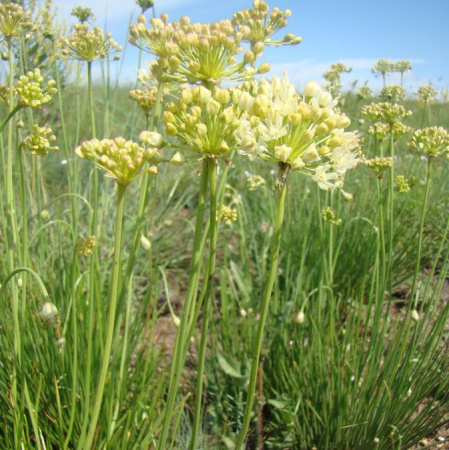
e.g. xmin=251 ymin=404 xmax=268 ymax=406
xmin=190 ymin=160 xmax=217 ymax=450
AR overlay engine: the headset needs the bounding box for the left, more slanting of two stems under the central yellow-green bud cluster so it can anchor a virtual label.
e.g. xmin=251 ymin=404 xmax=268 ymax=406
xmin=157 ymin=159 xmax=208 ymax=450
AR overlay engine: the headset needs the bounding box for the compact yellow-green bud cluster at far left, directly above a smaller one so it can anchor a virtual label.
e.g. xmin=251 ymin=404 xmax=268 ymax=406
xmin=16 ymin=69 xmax=58 ymax=109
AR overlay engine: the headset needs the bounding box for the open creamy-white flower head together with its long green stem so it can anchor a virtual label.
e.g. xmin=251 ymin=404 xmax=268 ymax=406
xmin=236 ymin=78 xmax=360 ymax=450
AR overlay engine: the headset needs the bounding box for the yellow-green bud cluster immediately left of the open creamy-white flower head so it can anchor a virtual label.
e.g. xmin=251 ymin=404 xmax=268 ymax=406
xmin=163 ymin=86 xmax=247 ymax=158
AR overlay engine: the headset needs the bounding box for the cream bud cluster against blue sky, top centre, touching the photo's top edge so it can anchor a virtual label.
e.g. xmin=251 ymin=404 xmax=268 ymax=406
xmin=232 ymin=0 xmax=301 ymax=49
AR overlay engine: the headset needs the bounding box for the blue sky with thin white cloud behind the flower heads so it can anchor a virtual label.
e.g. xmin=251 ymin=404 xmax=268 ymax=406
xmin=42 ymin=0 xmax=449 ymax=91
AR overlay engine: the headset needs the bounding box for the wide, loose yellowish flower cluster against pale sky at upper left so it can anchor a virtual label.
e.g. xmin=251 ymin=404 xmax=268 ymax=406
xmin=58 ymin=23 xmax=122 ymax=61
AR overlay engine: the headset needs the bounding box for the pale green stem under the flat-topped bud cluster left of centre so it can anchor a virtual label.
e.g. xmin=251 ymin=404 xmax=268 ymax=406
xmin=83 ymin=184 xmax=126 ymax=449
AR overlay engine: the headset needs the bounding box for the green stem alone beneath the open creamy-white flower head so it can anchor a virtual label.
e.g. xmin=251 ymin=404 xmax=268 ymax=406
xmin=235 ymin=165 xmax=290 ymax=450
